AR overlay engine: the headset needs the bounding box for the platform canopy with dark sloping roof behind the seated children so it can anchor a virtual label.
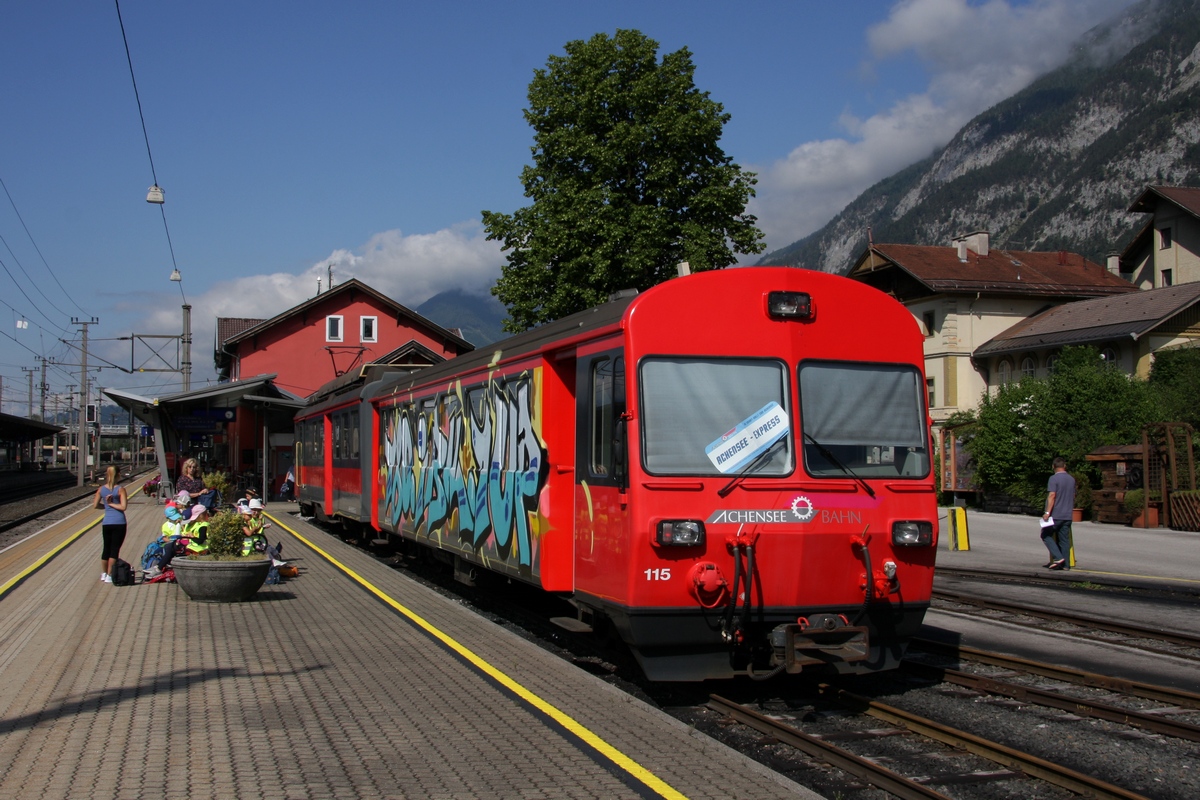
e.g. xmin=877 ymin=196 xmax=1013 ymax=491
xmin=104 ymin=374 xmax=305 ymax=497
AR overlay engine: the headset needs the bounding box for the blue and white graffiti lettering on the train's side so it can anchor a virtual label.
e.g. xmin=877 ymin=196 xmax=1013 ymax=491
xmin=379 ymin=372 xmax=547 ymax=567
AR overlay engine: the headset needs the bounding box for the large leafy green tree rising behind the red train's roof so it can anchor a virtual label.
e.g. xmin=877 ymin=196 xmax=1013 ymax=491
xmin=482 ymin=30 xmax=763 ymax=332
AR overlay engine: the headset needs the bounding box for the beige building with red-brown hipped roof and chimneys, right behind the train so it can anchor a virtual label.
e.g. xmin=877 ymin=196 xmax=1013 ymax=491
xmin=848 ymin=228 xmax=1132 ymax=425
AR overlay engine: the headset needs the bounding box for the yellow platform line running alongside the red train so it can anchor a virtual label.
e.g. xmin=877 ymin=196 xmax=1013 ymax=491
xmin=266 ymin=515 xmax=686 ymax=800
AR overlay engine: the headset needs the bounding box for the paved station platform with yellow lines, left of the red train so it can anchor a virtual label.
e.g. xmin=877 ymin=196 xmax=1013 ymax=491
xmin=0 ymin=493 xmax=820 ymax=800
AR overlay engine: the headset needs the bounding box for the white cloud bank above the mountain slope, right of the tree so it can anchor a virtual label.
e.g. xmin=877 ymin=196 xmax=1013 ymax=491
xmin=751 ymin=0 xmax=1132 ymax=249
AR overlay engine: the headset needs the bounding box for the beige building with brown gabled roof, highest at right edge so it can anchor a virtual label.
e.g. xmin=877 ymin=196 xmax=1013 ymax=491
xmin=1120 ymin=186 xmax=1200 ymax=289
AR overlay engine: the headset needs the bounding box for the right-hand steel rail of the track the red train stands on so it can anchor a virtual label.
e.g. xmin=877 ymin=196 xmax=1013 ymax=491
xmin=821 ymin=684 xmax=1147 ymax=800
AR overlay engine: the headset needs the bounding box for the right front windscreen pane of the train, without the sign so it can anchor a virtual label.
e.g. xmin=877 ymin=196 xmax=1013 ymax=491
xmin=799 ymin=361 xmax=930 ymax=479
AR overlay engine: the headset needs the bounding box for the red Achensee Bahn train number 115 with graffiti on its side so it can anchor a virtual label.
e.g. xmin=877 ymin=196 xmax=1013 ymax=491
xmin=296 ymin=267 xmax=937 ymax=680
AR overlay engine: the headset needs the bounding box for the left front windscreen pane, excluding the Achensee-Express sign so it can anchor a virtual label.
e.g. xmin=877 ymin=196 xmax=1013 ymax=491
xmin=638 ymin=356 xmax=793 ymax=476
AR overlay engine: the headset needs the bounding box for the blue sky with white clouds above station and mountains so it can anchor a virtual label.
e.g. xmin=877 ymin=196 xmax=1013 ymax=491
xmin=0 ymin=0 xmax=1130 ymax=415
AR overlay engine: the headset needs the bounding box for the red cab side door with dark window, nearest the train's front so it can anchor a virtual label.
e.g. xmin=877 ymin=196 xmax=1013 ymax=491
xmin=575 ymin=349 xmax=629 ymax=597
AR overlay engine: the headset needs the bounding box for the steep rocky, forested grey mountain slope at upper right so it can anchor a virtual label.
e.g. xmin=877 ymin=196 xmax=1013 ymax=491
xmin=760 ymin=0 xmax=1200 ymax=272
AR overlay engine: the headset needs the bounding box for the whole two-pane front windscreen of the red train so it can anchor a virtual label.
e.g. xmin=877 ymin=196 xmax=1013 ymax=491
xmin=640 ymin=357 xmax=930 ymax=479
